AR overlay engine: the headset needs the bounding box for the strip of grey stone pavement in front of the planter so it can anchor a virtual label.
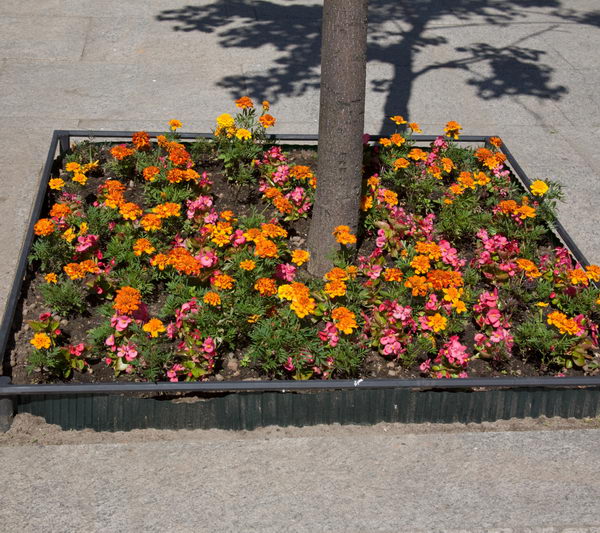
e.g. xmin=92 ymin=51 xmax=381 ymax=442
xmin=0 ymin=430 xmax=600 ymax=532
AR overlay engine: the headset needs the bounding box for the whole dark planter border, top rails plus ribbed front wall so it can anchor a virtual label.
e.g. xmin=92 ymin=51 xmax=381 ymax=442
xmin=0 ymin=130 xmax=600 ymax=431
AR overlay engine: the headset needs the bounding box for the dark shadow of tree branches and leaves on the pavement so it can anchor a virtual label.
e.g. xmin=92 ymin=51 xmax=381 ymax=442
xmin=156 ymin=0 xmax=600 ymax=132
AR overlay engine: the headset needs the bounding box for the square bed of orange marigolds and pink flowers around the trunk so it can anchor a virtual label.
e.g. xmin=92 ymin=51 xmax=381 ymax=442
xmin=2 ymin=98 xmax=600 ymax=394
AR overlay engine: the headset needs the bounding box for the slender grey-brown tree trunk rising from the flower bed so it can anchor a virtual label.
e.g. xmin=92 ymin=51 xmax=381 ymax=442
xmin=308 ymin=0 xmax=368 ymax=277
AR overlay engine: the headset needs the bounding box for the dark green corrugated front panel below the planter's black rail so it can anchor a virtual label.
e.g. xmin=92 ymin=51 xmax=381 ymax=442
xmin=11 ymin=388 xmax=600 ymax=431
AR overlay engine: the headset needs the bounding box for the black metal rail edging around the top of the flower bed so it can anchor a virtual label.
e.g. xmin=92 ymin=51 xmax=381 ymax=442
xmin=0 ymin=130 xmax=600 ymax=404
